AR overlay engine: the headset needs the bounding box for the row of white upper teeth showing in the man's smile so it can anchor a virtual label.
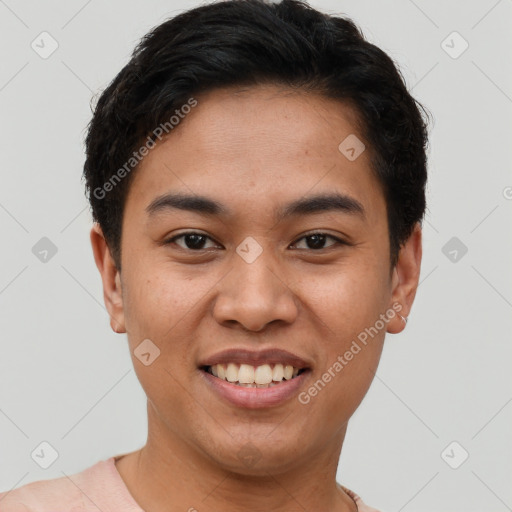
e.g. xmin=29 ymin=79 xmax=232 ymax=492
xmin=210 ymin=363 xmax=299 ymax=384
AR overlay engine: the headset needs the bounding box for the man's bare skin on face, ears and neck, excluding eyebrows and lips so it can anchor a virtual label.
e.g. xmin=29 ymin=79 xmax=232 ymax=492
xmin=91 ymin=85 xmax=422 ymax=512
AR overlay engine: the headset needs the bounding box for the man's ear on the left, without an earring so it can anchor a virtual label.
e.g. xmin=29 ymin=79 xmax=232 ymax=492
xmin=91 ymin=222 xmax=126 ymax=333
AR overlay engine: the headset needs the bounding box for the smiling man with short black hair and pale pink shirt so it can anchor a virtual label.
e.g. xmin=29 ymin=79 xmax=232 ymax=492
xmin=0 ymin=0 xmax=427 ymax=512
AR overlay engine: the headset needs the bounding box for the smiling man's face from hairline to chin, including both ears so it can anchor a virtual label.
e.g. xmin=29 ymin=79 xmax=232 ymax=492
xmin=91 ymin=86 xmax=421 ymax=474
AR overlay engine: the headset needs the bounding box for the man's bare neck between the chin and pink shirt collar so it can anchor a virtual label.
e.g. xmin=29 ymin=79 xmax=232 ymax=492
xmin=116 ymin=404 xmax=357 ymax=512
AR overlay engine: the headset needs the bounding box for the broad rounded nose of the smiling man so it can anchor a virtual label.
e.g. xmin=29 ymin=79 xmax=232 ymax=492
xmin=213 ymin=251 xmax=299 ymax=332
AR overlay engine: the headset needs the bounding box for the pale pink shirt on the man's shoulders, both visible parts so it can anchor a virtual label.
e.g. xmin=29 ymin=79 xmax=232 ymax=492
xmin=0 ymin=455 xmax=379 ymax=512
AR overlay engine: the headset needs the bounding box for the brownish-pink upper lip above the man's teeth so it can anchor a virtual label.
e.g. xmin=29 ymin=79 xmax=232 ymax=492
xmin=199 ymin=348 xmax=309 ymax=369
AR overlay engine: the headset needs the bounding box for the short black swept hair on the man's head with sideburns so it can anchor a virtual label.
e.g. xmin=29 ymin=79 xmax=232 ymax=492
xmin=83 ymin=0 xmax=429 ymax=270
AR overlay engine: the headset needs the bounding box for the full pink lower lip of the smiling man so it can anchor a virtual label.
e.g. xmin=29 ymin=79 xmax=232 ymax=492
xmin=199 ymin=370 xmax=309 ymax=409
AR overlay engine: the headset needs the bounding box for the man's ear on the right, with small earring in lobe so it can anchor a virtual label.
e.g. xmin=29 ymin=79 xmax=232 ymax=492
xmin=387 ymin=223 xmax=422 ymax=334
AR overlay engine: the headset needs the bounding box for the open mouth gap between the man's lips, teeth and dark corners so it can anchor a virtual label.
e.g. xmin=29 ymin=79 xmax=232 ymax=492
xmin=201 ymin=363 xmax=307 ymax=389
